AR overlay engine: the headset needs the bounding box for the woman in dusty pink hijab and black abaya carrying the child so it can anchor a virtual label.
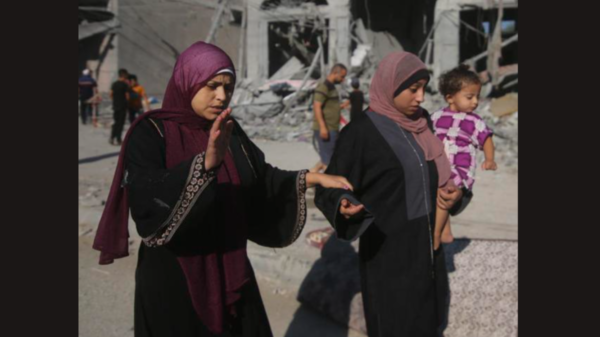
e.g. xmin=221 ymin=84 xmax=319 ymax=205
xmin=315 ymin=52 xmax=462 ymax=337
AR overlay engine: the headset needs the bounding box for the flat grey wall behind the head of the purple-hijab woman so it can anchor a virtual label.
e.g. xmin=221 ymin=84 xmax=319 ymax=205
xmin=113 ymin=0 xmax=242 ymax=95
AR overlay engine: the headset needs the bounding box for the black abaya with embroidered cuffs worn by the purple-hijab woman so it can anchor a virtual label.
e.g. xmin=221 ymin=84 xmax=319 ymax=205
xmin=125 ymin=119 xmax=306 ymax=337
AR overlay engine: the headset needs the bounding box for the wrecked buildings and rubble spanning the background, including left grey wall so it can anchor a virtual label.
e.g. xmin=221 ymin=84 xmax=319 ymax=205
xmin=79 ymin=0 xmax=518 ymax=167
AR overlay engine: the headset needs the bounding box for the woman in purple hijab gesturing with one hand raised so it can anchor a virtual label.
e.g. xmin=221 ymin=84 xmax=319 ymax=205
xmin=94 ymin=42 xmax=352 ymax=337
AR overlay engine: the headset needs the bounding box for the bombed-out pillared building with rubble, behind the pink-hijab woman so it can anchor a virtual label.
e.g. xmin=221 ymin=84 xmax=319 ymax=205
xmin=232 ymin=0 xmax=518 ymax=166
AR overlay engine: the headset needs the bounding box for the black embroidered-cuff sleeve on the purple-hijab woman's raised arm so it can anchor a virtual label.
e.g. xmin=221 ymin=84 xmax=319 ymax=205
xmin=124 ymin=120 xmax=216 ymax=247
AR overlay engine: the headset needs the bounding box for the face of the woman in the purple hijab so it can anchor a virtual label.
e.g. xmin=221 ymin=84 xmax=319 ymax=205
xmin=192 ymin=74 xmax=234 ymax=121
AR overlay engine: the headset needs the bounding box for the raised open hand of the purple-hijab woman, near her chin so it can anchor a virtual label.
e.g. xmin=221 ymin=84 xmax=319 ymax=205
xmin=204 ymin=108 xmax=233 ymax=170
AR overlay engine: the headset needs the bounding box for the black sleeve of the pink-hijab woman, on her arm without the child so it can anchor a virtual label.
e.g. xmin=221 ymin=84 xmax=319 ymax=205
xmin=315 ymin=125 xmax=374 ymax=241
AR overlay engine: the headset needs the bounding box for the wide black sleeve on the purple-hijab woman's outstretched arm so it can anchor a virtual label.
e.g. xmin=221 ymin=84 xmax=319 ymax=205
xmin=236 ymin=125 xmax=308 ymax=247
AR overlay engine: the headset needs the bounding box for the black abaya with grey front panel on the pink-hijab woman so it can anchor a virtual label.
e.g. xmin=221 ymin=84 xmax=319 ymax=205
xmin=315 ymin=111 xmax=447 ymax=337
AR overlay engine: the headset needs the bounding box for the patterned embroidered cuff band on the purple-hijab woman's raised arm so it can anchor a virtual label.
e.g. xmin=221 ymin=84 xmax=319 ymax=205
xmin=143 ymin=152 xmax=215 ymax=247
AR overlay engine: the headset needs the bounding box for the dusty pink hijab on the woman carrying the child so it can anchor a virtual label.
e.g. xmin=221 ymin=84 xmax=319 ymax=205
xmin=369 ymin=52 xmax=451 ymax=187
